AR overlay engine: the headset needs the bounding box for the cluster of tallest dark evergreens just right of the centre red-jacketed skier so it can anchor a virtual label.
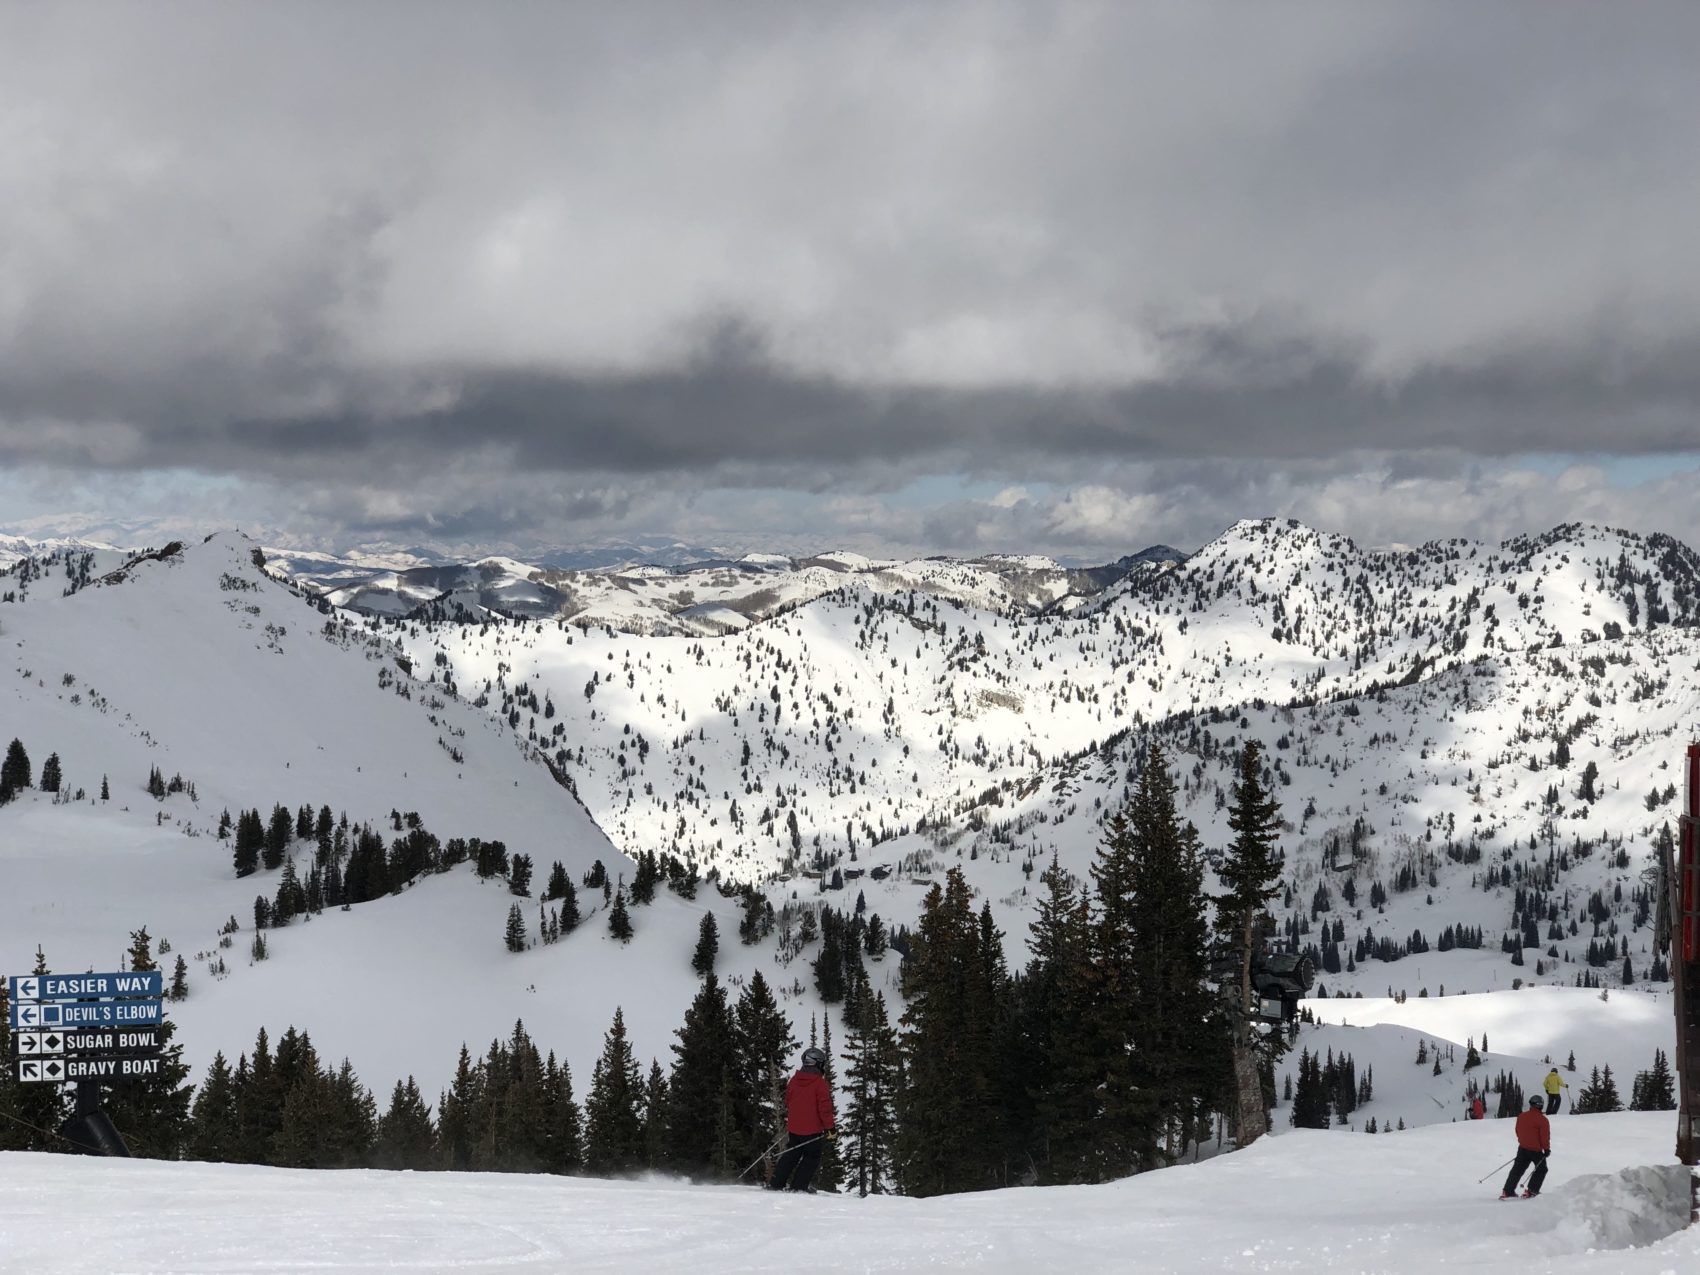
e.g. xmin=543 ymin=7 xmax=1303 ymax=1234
xmin=893 ymin=745 xmax=1284 ymax=1195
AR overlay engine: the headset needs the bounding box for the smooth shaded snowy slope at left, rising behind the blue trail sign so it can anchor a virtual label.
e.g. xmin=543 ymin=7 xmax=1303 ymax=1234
xmin=0 ymin=534 xmax=649 ymax=1101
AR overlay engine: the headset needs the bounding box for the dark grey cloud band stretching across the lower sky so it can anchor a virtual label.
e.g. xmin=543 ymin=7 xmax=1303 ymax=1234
xmin=16 ymin=314 xmax=1700 ymax=486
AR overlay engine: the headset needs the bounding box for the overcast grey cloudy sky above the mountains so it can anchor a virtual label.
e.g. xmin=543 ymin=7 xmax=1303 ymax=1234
xmin=0 ymin=0 xmax=1700 ymax=558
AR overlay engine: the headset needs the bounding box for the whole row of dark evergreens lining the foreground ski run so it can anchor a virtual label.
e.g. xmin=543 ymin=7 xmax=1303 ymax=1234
xmin=0 ymin=745 xmax=1285 ymax=1195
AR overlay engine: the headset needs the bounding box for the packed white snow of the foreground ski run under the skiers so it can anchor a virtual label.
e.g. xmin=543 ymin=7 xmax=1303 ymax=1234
xmin=0 ymin=1114 xmax=1700 ymax=1275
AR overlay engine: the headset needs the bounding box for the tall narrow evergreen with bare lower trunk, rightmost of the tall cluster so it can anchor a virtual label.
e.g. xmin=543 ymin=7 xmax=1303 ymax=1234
xmin=1216 ymin=741 xmax=1282 ymax=1148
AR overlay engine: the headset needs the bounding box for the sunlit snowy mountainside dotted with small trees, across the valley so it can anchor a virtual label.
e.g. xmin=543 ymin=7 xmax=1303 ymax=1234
xmin=394 ymin=522 xmax=1700 ymax=993
